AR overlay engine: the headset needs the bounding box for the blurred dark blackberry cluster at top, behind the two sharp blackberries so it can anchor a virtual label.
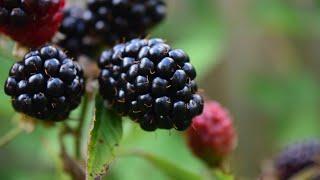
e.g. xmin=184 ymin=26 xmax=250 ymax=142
xmin=58 ymin=0 xmax=166 ymax=58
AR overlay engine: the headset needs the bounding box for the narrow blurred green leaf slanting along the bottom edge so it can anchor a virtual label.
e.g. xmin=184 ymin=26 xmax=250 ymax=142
xmin=133 ymin=151 xmax=202 ymax=180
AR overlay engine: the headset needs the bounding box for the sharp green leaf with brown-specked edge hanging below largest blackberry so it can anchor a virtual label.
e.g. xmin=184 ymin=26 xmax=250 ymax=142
xmin=86 ymin=96 xmax=122 ymax=180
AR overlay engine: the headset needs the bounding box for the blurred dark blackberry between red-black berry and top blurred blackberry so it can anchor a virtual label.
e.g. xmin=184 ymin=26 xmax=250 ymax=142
xmin=57 ymin=7 xmax=100 ymax=58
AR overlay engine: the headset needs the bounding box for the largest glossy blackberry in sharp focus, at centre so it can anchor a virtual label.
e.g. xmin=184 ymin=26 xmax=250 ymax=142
xmin=99 ymin=39 xmax=203 ymax=131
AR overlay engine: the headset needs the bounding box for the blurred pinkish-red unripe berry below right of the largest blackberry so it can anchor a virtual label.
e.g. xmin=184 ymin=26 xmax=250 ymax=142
xmin=187 ymin=101 xmax=236 ymax=166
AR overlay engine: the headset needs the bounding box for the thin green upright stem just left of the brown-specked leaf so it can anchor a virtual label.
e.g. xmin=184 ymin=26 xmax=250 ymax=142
xmin=75 ymin=93 xmax=89 ymax=159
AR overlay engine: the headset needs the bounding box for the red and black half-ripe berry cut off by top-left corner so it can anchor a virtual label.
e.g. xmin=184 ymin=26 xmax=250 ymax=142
xmin=0 ymin=0 xmax=65 ymax=47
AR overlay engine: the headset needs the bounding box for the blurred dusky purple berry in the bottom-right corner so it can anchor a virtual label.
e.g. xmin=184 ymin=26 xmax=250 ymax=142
xmin=275 ymin=141 xmax=320 ymax=180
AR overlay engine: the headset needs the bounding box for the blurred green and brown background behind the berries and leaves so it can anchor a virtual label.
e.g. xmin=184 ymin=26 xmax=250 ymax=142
xmin=0 ymin=0 xmax=320 ymax=180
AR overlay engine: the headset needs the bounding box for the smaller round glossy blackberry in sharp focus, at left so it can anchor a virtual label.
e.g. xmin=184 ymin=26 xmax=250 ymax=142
xmin=4 ymin=45 xmax=84 ymax=121
